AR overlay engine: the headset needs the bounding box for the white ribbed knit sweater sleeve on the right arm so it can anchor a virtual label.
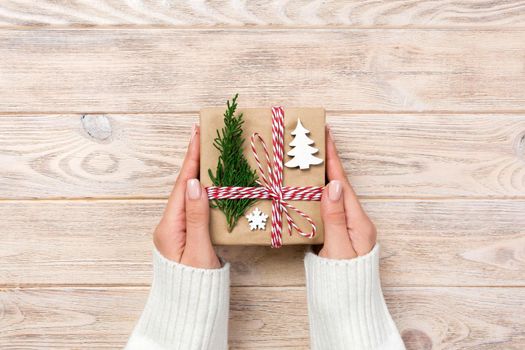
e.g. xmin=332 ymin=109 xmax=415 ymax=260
xmin=305 ymin=244 xmax=405 ymax=350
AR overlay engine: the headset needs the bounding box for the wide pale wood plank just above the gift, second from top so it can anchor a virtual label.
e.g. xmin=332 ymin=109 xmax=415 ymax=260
xmin=0 ymin=29 xmax=525 ymax=113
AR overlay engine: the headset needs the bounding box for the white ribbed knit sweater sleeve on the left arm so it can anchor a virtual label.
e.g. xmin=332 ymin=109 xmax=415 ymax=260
xmin=126 ymin=250 xmax=230 ymax=350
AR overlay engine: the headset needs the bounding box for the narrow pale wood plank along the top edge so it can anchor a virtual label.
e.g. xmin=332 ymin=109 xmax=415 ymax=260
xmin=0 ymin=0 xmax=525 ymax=27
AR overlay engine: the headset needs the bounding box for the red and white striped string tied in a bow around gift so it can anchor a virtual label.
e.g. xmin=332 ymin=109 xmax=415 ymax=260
xmin=206 ymin=107 xmax=323 ymax=248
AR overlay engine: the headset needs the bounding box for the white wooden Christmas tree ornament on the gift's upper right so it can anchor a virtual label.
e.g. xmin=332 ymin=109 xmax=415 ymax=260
xmin=284 ymin=118 xmax=323 ymax=170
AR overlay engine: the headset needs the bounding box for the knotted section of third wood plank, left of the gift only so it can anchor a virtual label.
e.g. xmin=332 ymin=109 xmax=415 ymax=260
xmin=0 ymin=114 xmax=193 ymax=198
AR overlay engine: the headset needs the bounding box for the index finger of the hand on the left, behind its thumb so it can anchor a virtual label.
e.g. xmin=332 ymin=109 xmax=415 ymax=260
xmin=163 ymin=124 xmax=200 ymax=229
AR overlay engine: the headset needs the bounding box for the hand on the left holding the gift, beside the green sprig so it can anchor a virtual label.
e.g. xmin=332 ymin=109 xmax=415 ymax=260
xmin=153 ymin=125 xmax=221 ymax=269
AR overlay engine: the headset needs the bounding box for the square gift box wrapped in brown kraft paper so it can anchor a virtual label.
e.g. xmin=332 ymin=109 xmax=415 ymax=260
xmin=200 ymin=102 xmax=325 ymax=247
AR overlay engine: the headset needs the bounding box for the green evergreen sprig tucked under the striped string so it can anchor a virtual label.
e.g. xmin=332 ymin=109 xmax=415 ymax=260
xmin=208 ymin=94 xmax=258 ymax=232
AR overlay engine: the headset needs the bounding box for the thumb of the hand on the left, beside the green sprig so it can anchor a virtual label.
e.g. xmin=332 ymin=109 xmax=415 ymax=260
xmin=181 ymin=179 xmax=220 ymax=268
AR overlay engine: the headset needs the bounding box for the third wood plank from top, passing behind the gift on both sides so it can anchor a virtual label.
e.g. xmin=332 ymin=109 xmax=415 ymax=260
xmin=0 ymin=112 xmax=525 ymax=199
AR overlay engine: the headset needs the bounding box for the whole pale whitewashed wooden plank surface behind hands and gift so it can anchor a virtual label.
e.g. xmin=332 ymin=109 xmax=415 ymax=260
xmin=0 ymin=0 xmax=525 ymax=350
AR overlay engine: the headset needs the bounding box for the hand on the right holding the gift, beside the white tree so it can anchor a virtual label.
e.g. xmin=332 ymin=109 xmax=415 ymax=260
xmin=319 ymin=127 xmax=376 ymax=259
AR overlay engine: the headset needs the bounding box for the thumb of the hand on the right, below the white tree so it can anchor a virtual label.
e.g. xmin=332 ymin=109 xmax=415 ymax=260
xmin=319 ymin=180 xmax=357 ymax=259
